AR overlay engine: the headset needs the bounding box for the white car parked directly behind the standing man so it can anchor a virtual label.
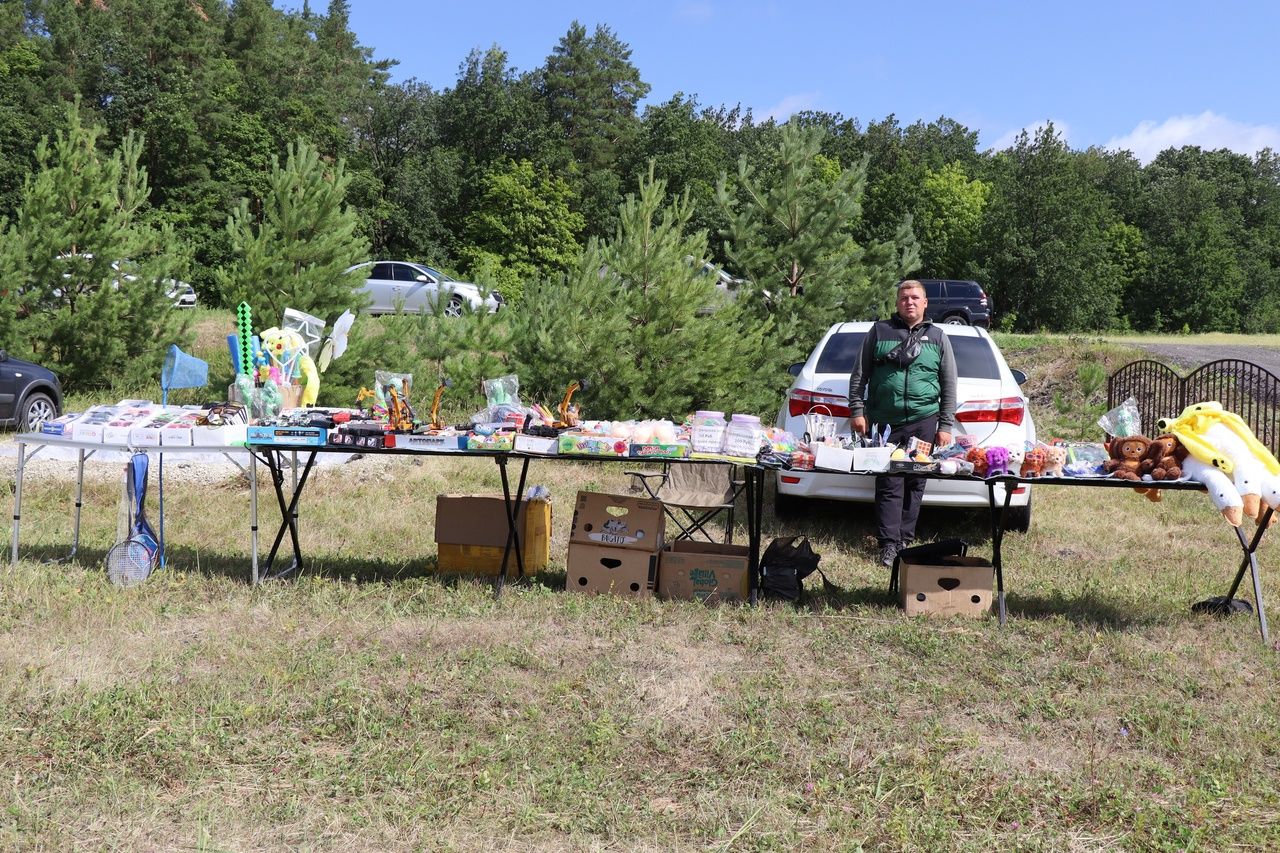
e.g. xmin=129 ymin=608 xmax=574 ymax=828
xmin=777 ymin=323 xmax=1036 ymax=532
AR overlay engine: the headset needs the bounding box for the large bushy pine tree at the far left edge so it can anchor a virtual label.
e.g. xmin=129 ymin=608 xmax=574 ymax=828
xmin=6 ymin=102 xmax=188 ymax=391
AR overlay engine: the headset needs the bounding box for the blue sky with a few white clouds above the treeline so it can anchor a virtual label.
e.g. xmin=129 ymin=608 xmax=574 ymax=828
xmin=345 ymin=0 xmax=1280 ymax=161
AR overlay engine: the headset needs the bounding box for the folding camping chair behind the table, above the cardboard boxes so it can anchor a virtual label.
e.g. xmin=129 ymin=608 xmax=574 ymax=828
xmin=627 ymin=462 xmax=746 ymax=544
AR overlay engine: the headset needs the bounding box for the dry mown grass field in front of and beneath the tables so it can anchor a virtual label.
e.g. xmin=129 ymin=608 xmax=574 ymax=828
xmin=0 ymin=330 xmax=1280 ymax=850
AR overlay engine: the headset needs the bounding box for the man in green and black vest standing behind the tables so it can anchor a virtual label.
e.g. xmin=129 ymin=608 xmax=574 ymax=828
xmin=849 ymin=279 xmax=956 ymax=566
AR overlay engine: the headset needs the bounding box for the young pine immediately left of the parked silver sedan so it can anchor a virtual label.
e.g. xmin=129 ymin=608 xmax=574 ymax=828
xmin=220 ymin=140 xmax=369 ymax=325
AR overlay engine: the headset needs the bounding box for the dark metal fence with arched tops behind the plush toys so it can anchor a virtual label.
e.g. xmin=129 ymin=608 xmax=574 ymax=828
xmin=1107 ymin=359 xmax=1280 ymax=455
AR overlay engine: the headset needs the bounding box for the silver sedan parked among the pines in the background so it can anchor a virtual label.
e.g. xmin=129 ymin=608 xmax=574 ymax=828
xmin=347 ymin=261 xmax=503 ymax=316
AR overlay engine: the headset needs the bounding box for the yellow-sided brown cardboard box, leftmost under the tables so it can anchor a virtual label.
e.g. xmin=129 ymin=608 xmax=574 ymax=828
xmin=435 ymin=494 xmax=552 ymax=578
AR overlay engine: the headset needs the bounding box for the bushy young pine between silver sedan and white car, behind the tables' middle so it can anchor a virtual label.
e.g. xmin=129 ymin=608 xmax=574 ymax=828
xmin=513 ymin=168 xmax=781 ymax=419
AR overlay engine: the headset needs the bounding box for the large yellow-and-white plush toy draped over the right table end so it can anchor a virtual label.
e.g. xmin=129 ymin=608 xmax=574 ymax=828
xmin=1158 ymin=402 xmax=1280 ymax=524
